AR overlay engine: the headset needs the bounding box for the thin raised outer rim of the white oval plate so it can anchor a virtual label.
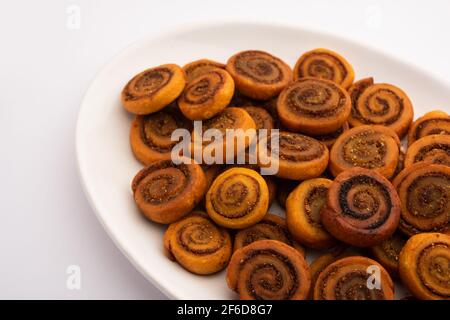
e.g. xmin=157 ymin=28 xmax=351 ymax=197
xmin=75 ymin=19 xmax=450 ymax=299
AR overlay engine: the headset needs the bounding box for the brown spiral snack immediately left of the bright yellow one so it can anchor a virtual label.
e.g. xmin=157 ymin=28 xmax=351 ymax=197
xmin=131 ymin=160 xmax=206 ymax=224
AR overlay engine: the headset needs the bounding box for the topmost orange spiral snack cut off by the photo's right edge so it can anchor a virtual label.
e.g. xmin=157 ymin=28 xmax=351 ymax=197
xmin=408 ymin=110 xmax=450 ymax=146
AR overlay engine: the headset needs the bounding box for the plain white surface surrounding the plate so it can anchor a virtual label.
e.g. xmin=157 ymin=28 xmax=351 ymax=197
xmin=0 ymin=0 xmax=450 ymax=299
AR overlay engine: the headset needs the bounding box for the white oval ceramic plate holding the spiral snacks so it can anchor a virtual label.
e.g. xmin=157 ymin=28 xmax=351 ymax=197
xmin=76 ymin=23 xmax=450 ymax=299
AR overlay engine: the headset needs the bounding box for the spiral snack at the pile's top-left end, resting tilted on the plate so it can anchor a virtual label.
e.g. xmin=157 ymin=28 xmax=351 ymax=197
xmin=121 ymin=64 xmax=186 ymax=115
